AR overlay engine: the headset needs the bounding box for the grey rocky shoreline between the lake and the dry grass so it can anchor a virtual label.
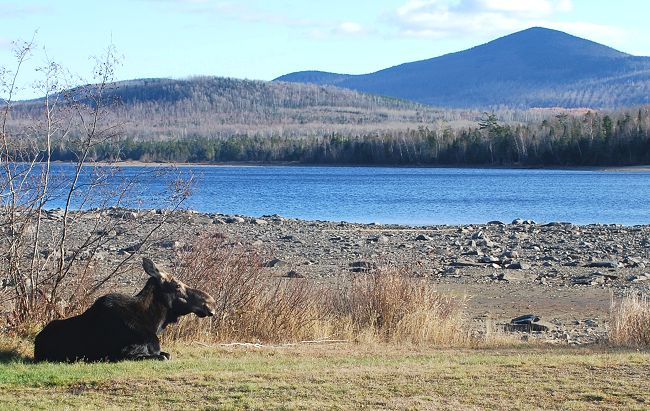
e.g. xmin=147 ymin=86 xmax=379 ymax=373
xmin=17 ymin=209 xmax=650 ymax=344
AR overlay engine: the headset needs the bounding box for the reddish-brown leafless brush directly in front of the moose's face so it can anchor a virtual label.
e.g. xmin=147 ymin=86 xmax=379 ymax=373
xmin=171 ymin=233 xmax=318 ymax=342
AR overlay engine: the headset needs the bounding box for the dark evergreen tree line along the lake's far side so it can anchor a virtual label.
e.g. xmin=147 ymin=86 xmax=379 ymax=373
xmin=41 ymin=107 xmax=650 ymax=166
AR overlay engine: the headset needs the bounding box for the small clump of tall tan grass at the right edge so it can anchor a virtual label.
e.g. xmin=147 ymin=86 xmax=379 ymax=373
xmin=608 ymin=294 xmax=650 ymax=348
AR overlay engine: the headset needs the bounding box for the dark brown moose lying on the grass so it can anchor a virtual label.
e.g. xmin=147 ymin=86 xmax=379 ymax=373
xmin=34 ymin=258 xmax=215 ymax=361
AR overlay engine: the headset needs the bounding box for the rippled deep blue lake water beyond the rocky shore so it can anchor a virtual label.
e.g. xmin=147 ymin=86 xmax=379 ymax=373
xmin=39 ymin=164 xmax=650 ymax=225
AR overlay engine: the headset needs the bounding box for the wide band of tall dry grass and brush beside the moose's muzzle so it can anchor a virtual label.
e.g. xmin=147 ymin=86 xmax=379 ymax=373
xmin=166 ymin=234 xmax=469 ymax=346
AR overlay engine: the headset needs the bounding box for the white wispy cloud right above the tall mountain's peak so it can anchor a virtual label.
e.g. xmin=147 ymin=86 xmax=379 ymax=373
xmin=389 ymin=0 xmax=626 ymax=40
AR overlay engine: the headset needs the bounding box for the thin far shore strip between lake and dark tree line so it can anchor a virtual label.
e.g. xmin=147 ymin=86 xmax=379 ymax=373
xmin=69 ymin=161 xmax=650 ymax=173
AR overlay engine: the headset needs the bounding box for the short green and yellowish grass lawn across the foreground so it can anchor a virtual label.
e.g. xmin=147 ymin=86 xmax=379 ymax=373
xmin=0 ymin=344 xmax=650 ymax=410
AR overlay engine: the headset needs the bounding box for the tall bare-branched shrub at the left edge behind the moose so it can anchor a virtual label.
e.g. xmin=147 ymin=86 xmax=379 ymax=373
xmin=0 ymin=40 xmax=191 ymax=328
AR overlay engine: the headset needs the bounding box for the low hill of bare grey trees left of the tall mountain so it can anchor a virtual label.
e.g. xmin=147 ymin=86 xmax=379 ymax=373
xmin=13 ymin=77 xmax=438 ymax=139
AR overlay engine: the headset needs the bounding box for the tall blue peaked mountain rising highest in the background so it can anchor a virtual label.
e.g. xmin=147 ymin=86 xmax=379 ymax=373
xmin=275 ymin=27 xmax=650 ymax=108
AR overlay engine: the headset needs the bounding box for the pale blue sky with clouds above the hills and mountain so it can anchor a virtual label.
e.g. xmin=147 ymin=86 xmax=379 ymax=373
xmin=0 ymin=0 xmax=650 ymax=99
